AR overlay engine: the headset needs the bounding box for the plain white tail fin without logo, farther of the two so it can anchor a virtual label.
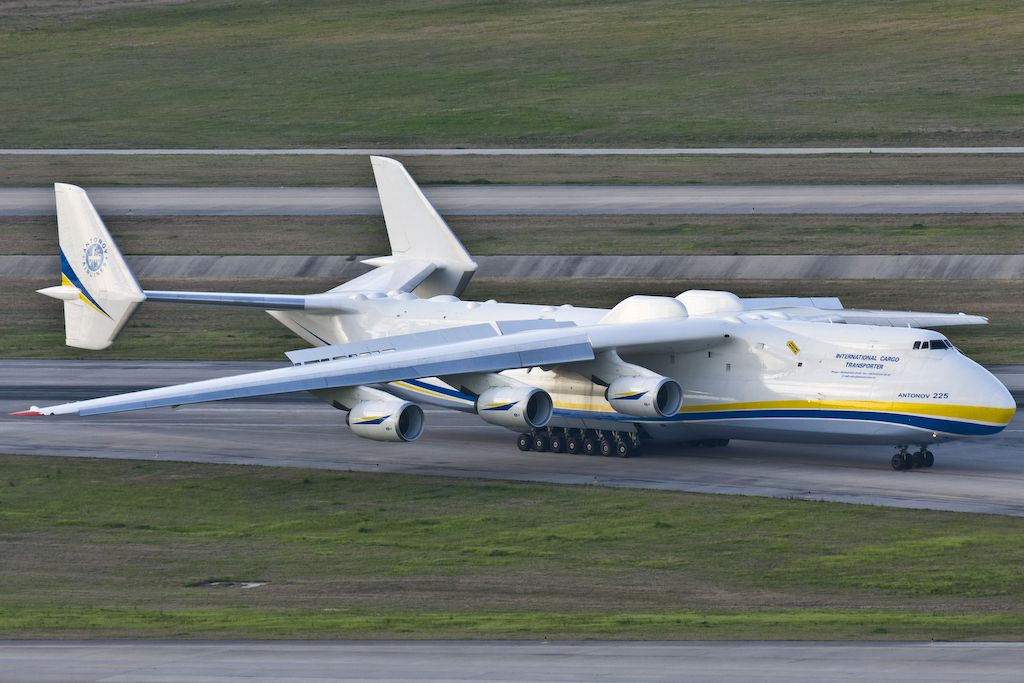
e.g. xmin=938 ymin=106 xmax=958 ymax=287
xmin=370 ymin=157 xmax=476 ymax=297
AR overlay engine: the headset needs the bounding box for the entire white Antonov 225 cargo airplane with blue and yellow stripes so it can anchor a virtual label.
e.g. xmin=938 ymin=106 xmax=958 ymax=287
xmin=15 ymin=157 xmax=1016 ymax=470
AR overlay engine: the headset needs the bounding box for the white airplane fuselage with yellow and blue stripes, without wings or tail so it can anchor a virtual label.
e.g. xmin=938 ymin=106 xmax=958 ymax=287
xmin=274 ymin=294 xmax=1016 ymax=445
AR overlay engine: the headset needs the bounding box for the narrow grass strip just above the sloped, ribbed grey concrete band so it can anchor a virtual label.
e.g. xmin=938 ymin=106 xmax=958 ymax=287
xmin=8 ymin=214 xmax=1024 ymax=256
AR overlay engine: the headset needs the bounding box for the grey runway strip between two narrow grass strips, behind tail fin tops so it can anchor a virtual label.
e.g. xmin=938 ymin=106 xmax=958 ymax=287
xmin=0 ymin=184 xmax=1024 ymax=216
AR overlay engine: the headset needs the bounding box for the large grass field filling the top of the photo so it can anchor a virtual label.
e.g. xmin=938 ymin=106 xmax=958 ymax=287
xmin=0 ymin=0 xmax=1024 ymax=147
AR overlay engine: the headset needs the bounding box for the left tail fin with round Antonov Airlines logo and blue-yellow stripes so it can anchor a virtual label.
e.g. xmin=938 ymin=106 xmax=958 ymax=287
xmin=40 ymin=182 xmax=145 ymax=349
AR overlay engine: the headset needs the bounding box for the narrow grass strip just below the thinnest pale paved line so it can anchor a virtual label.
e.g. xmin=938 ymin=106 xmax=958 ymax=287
xmin=0 ymin=155 xmax=1024 ymax=188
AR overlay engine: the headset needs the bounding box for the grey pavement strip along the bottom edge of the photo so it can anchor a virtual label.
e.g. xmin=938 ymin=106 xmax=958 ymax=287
xmin=0 ymin=641 xmax=1024 ymax=683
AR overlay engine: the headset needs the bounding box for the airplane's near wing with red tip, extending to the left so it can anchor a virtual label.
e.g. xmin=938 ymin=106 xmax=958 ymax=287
xmin=13 ymin=321 xmax=723 ymax=416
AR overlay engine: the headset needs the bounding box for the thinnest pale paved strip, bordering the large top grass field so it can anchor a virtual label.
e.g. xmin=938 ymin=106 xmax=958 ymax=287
xmin=6 ymin=146 xmax=1024 ymax=157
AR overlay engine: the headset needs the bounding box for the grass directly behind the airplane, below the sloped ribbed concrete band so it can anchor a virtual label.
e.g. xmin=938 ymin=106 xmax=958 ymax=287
xmin=0 ymin=279 xmax=1024 ymax=364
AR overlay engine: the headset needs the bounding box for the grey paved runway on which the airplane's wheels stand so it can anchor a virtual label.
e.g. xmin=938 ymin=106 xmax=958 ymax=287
xmin=0 ymin=360 xmax=1024 ymax=515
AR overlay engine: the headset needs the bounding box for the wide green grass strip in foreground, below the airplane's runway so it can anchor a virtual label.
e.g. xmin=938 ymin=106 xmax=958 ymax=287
xmin=0 ymin=456 xmax=1024 ymax=639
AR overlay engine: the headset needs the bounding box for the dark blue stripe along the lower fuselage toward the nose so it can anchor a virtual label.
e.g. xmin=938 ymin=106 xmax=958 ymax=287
xmin=555 ymin=409 xmax=1006 ymax=436
